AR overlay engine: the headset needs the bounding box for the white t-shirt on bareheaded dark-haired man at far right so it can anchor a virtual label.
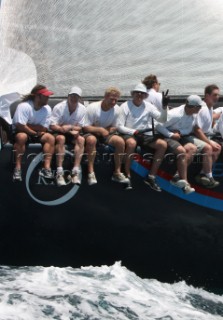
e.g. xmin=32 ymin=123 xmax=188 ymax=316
xmin=195 ymin=101 xmax=213 ymax=134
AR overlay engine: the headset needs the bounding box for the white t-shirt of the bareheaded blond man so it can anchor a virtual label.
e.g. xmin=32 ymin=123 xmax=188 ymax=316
xmin=84 ymin=101 xmax=120 ymax=128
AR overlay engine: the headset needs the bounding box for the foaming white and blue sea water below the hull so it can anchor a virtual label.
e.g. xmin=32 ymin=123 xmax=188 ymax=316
xmin=0 ymin=262 xmax=223 ymax=320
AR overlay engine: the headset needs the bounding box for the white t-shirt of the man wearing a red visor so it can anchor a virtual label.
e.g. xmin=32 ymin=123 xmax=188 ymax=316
xmin=12 ymin=100 xmax=52 ymax=129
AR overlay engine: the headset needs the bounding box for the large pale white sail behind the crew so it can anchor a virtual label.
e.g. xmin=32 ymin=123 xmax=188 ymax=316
xmin=0 ymin=0 xmax=223 ymax=96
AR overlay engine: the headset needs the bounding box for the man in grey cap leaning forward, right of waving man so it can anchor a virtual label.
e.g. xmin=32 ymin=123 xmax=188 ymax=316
xmin=156 ymin=95 xmax=206 ymax=194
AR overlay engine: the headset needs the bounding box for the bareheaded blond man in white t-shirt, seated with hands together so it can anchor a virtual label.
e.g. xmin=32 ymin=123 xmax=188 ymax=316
xmin=83 ymin=87 xmax=129 ymax=185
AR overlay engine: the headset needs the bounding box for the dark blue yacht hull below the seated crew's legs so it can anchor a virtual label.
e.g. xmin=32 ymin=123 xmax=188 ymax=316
xmin=0 ymin=144 xmax=223 ymax=288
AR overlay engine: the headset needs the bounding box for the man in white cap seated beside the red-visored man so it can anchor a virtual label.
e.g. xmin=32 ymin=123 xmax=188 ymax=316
xmin=50 ymin=86 xmax=86 ymax=186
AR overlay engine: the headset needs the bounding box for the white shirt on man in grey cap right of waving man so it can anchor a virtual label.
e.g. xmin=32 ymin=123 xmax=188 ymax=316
xmin=156 ymin=104 xmax=196 ymax=138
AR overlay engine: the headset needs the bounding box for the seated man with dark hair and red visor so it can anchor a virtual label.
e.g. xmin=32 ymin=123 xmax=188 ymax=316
xmin=12 ymin=84 xmax=55 ymax=181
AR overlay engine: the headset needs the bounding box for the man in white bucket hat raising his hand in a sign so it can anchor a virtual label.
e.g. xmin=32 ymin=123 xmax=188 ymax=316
xmin=118 ymin=83 xmax=167 ymax=191
